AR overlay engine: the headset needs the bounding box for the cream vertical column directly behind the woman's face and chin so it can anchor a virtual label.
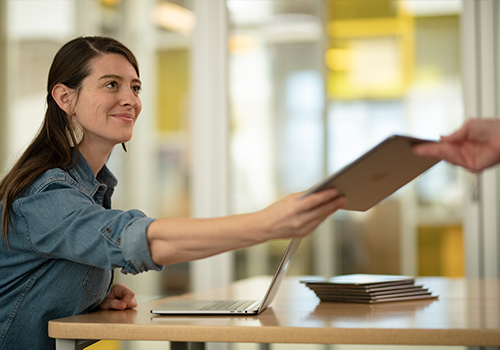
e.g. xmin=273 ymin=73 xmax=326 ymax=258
xmin=113 ymin=0 xmax=161 ymax=298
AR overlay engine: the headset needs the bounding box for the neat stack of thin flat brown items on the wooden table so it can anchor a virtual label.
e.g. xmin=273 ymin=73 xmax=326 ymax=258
xmin=301 ymin=274 xmax=437 ymax=304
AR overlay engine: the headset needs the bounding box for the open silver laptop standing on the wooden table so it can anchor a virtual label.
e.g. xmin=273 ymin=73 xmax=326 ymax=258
xmin=151 ymin=238 xmax=301 ymax=315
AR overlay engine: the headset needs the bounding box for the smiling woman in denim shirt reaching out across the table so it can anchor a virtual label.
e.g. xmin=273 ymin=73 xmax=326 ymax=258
xmin=0 ymin=37 xmax=345 ymax=349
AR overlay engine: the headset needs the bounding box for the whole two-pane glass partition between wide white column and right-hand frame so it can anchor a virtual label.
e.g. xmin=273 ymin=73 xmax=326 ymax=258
xmin=228 ymin=0 xmax=464 ymax=278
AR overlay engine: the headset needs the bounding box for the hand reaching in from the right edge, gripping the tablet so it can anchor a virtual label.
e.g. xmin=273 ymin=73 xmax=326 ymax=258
xmin=413 ymin=119 xmax=500 ymax=172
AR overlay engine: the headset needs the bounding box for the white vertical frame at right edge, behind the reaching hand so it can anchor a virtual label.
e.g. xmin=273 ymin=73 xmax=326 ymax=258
xmin=462 ymin=0 xmax=499 ymax=277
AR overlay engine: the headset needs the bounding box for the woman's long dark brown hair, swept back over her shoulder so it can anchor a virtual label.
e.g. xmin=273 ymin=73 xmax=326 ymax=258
xmin=0 ymin=37 xmax=139 ymax=247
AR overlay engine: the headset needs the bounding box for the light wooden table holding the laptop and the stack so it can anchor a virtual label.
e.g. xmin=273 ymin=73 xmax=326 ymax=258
xmin=49 ymin=277 xmax=500 ymax=349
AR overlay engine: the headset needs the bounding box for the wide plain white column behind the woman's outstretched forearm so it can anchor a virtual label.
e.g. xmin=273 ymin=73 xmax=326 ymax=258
xmin=190 ymin=0 xmax=233 ymax=291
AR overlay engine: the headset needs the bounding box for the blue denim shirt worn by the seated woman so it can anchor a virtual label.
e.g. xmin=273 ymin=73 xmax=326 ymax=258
xmin=0 ymin=155 xmax=161 ymax=350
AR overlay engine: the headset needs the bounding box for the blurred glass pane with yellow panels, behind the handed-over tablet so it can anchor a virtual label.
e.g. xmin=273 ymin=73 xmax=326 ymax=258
xmin=326 ymin=0 xmax=464 ymax=276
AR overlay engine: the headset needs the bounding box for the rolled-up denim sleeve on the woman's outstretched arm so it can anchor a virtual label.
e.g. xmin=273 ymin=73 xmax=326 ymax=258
xmin=13 ymin=174 xmax=162 ymax=274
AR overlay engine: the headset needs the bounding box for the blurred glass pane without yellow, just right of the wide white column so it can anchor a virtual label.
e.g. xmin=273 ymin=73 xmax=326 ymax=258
xmin=227 ymin=1 xmax=325 ymax=279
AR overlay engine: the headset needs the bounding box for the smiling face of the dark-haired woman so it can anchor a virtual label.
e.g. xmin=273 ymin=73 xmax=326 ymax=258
xmin=73 ymin=54 xmax=142 ymax=148
